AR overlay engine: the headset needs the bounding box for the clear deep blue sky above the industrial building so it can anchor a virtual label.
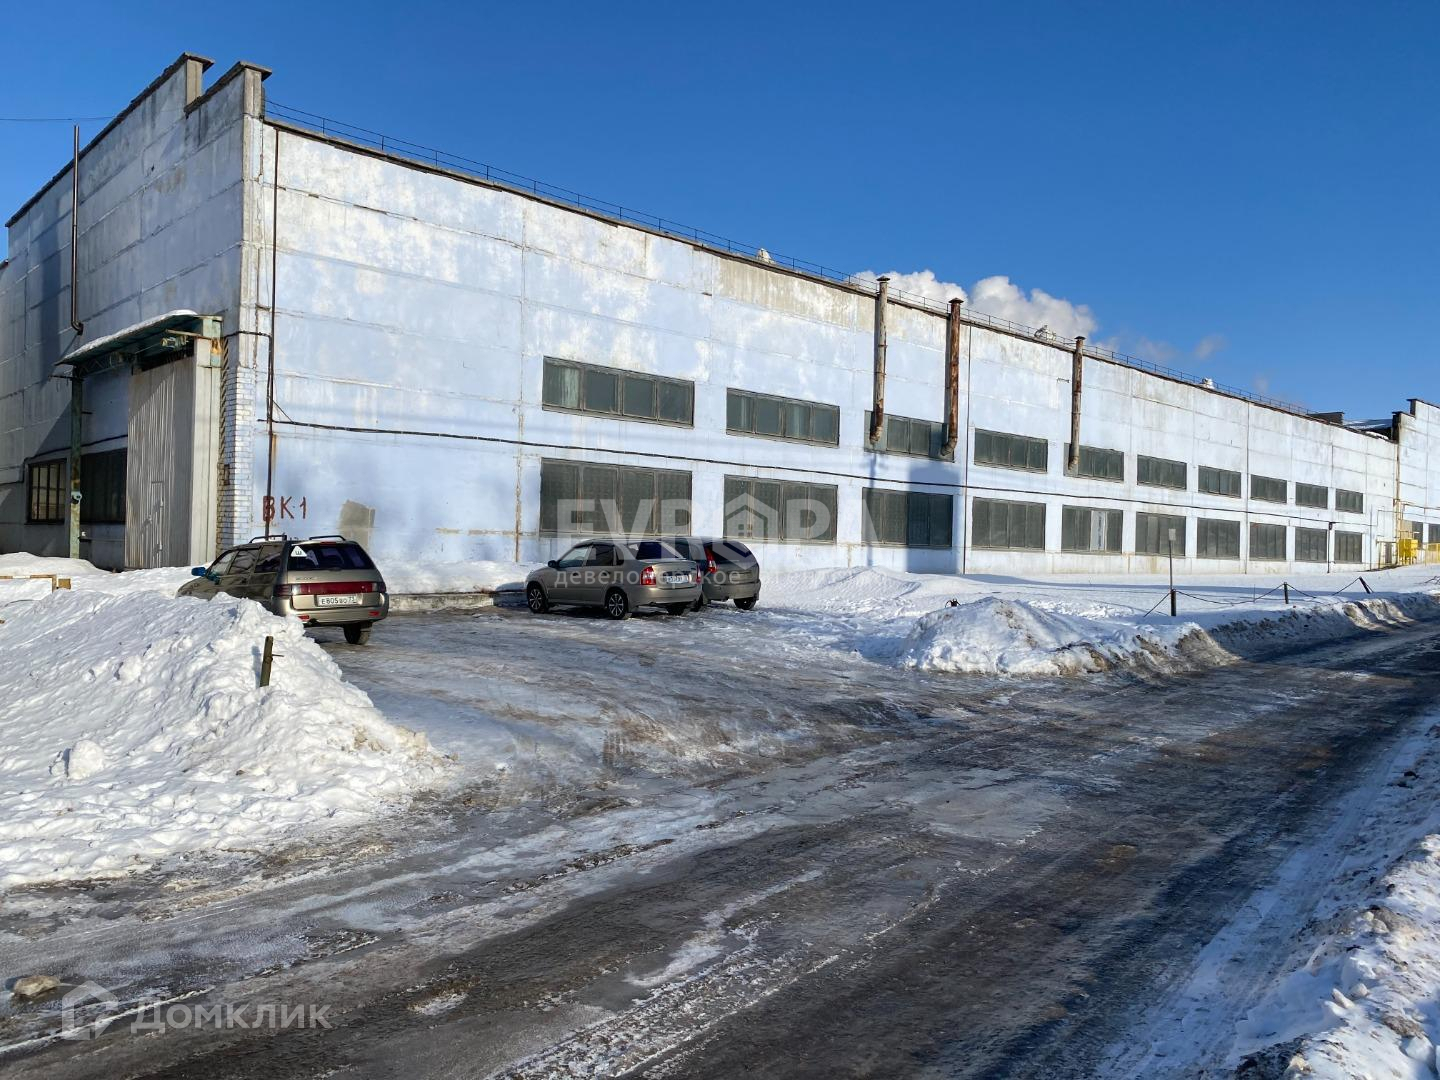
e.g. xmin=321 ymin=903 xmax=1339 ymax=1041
xmin=0 ymin=0 xmax=1440 ymax=416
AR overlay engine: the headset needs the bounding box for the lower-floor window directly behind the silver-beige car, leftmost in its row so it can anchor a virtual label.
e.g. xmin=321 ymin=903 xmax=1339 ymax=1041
xmin=540 ymin=458 xmax=691 ymax=536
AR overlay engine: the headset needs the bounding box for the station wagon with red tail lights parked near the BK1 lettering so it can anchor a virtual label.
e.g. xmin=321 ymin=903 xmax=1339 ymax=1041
xmin=179 ymin=536 xmax=390 ymax=645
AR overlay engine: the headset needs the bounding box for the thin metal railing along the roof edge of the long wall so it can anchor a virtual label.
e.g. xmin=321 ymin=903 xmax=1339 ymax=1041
xmin=265 ymin=101 xmax=1313 ymax=419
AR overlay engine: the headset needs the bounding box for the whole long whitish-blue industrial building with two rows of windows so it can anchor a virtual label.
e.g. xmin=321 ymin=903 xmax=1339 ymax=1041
xmin=0 ymin=55 xmax=1440 ymax=584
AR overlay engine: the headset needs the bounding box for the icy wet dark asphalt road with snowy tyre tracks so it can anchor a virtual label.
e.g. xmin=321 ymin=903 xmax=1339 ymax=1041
xmin=8 ymin=611 xmax=1440 ymax=1080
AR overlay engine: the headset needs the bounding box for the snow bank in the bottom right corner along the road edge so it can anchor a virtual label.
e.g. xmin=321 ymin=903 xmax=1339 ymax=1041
xmin=1238 ymin=716 xmax=1440 ymax=1080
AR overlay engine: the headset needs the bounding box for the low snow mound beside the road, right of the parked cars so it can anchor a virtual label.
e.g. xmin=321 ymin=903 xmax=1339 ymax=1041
xmin=900 ymin=596 xmax=1201 ymax=675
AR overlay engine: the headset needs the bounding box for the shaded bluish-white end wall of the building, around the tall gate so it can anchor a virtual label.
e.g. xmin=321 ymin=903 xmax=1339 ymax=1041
xmin=0 ymin=59 xmax=243 ymax=566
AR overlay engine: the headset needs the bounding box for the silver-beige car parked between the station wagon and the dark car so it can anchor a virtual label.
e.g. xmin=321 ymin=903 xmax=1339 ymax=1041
xmin=526 ymin=539 xmax=700 ymax=619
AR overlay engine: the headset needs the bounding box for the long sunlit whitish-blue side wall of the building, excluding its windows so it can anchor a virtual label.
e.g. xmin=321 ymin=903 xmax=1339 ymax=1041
xmin=238 ymin=127 xmax=1395 ymax=573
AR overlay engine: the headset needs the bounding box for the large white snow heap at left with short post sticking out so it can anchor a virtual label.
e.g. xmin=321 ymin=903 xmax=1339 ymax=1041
xmin=0 ymin=584 xmax=441 ymax=887
